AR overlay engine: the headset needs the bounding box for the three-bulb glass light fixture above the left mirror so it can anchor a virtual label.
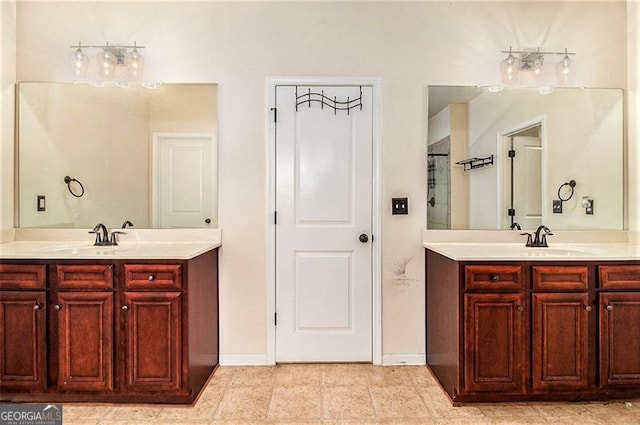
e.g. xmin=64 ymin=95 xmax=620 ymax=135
xmin=70 ymin=41 xmax=144 ymax=80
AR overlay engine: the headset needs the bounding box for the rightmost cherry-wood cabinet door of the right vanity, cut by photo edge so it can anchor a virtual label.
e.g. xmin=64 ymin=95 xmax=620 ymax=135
xmin=600 ymin=292 xmax=640 ymax=387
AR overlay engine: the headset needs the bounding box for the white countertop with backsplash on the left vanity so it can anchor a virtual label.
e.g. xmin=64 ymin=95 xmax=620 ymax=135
xmin=0 ymin=229 xmax=222 ymax=260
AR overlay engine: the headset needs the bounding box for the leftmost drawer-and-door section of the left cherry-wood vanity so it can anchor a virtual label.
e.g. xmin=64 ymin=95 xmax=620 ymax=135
xmin=0 ymin=264 xmax=47 ymax=390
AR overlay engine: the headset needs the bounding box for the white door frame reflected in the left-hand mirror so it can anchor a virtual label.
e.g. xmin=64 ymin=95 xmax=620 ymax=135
xmin=149 ymin=131 xmax=218 ymax=228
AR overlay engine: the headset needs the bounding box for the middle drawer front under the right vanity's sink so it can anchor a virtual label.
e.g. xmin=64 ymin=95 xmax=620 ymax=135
xmin=533 ymin=266 xmax=589 ymax=291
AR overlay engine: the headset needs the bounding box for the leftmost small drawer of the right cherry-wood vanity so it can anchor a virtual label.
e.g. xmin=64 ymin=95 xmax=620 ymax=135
xmin=464 ymin=265 xmax=523 ymax=291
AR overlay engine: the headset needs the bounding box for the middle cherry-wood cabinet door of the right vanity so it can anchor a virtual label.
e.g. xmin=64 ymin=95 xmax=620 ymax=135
xmin=533 ymin=293 xmax=595 ymax=390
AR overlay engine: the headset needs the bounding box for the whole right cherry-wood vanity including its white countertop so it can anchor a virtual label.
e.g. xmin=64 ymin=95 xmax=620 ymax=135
xmin=423 ymin=231 xmax=640 ymax=404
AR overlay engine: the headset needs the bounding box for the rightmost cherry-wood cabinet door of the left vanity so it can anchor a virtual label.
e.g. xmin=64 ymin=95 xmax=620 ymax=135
xmin=122 ymin=292 xmax=182 ymax=391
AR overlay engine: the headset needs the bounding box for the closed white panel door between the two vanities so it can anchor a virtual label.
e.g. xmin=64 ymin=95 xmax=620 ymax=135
xmin=276 ymin=86 xmax=373 ymax=362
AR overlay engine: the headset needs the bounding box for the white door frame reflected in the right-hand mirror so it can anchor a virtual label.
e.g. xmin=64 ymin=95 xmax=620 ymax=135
xmin=496 ymin=114 xmax=547 ymax=230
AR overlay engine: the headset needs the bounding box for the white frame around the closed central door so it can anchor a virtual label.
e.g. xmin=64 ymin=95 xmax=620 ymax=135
xmin=265 ymin=77 xmax=382 ymax=365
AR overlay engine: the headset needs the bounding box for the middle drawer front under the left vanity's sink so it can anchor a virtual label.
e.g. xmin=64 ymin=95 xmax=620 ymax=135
xmin=56 ymin=264 xmax=113 ymax=290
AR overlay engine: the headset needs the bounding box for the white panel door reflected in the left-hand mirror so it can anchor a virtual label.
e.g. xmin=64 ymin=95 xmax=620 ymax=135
xmin=152 ymin=133 xmax=215 ymax=229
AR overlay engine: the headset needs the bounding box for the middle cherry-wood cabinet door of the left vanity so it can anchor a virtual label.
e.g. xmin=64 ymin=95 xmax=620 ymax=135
xmin=54 ymin=292 xmax=114 ymax=391
